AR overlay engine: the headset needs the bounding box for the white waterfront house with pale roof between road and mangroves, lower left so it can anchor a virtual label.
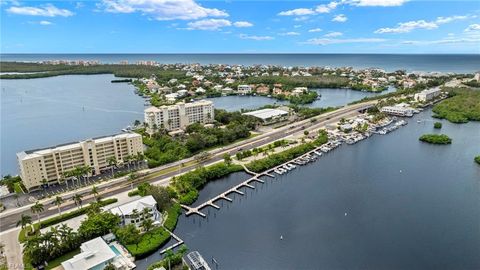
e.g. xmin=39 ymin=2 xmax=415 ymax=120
xmin=110 ymin=195 xmax=162 ymax=227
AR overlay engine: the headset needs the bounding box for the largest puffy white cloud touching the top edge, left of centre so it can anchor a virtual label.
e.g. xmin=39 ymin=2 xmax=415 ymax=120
xmin=98 ymin=0 xmax=228 ymax=20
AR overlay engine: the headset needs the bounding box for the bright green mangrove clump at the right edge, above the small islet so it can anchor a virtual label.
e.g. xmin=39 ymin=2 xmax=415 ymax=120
xmin=432 ymin=88 xmax=480 ymax=123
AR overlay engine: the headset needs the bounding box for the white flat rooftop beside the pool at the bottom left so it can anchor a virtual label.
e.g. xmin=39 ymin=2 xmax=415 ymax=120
xmin=62 ymin=237 xmax=117 ymax=270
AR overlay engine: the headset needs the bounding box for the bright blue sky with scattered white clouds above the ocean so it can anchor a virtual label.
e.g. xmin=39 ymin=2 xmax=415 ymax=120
xmin=0 ymin=0 xmax=480 ymax=54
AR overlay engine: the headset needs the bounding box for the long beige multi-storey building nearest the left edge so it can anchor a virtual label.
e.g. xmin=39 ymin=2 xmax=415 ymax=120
xmin=17 ymin=133 xmax=143 ymax=190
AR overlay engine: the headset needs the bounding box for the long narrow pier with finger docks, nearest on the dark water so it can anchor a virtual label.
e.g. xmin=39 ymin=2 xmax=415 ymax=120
xmin=181 ymin=144 xmax=326 ymax=218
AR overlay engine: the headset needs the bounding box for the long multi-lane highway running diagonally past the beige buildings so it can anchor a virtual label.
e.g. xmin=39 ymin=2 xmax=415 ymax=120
xmin=0 ymin=102 xmax=374 ymax=232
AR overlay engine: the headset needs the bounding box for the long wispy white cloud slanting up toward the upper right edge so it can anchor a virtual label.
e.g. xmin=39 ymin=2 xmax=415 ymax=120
xmin=374 ymin=15 xmax=476 ymax=34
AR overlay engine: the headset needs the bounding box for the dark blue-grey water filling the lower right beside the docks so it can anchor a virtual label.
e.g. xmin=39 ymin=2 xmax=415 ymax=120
xmin=137 ymin=111 xmax=480 ymax=269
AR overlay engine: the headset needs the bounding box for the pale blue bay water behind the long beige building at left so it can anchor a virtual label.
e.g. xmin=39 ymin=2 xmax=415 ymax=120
xmin=0 ymin=75 xmax=144 ymax=175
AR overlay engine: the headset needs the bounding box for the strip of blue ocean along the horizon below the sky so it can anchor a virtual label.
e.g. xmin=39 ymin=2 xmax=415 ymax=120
xmin=0 ymin=54 xmax=480 ymax=73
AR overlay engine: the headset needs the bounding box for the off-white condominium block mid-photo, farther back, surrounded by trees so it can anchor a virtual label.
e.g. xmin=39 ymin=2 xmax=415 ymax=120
xmin=145 ymin=100 xmax=214 ymax=133
